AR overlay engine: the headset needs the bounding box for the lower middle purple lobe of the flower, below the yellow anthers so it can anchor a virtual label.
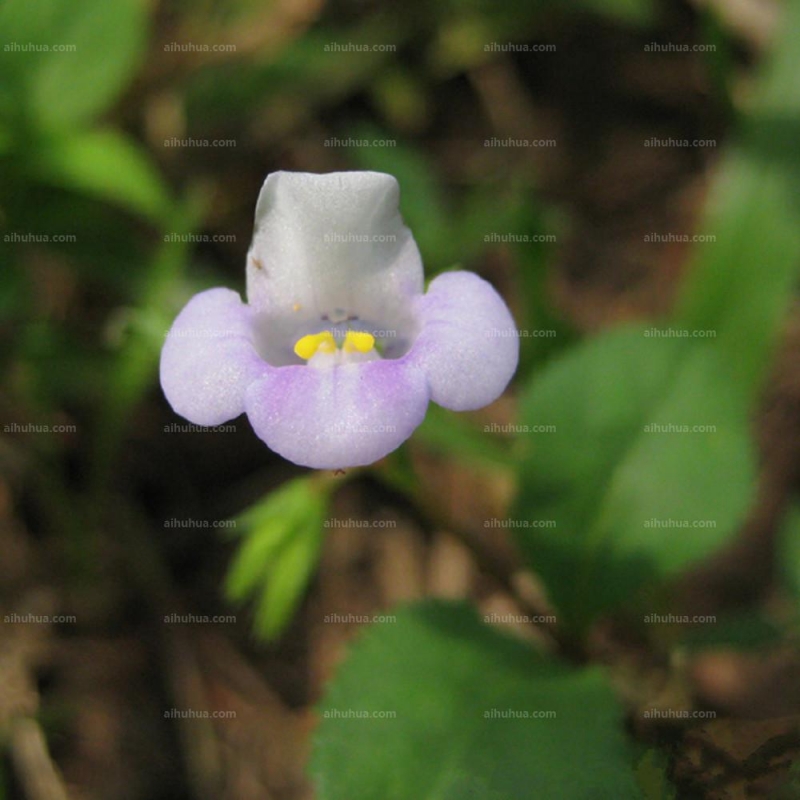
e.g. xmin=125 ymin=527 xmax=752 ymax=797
xmin=246 ymin=360 xmax=428 ymax=469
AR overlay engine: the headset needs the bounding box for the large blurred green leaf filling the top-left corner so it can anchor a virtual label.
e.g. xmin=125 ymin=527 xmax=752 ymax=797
xmin=0 ymin=0 xmax=147 ymax=131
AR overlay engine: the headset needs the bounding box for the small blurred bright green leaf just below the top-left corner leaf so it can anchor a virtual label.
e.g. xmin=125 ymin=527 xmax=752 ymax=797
xmin=30 ymin=130 xmax=171 ymax=224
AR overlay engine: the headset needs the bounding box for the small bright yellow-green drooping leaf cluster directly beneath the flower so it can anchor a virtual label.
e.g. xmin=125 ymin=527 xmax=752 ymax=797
xmin=225 ymin=478 xmax=333 ymax=639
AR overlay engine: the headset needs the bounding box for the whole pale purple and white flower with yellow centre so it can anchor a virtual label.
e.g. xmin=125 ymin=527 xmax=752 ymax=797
xmin=161 ymin=172 xmax=519 ymax=469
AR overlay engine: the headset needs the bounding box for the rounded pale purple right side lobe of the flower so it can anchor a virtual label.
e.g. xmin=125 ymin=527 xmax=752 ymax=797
xmin=404 ymin=272 xmax=519 ymax=411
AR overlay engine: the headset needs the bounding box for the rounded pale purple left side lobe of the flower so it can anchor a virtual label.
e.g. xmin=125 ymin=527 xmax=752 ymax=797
xmin=161 ymin=289 xmax=270 ymax=425
